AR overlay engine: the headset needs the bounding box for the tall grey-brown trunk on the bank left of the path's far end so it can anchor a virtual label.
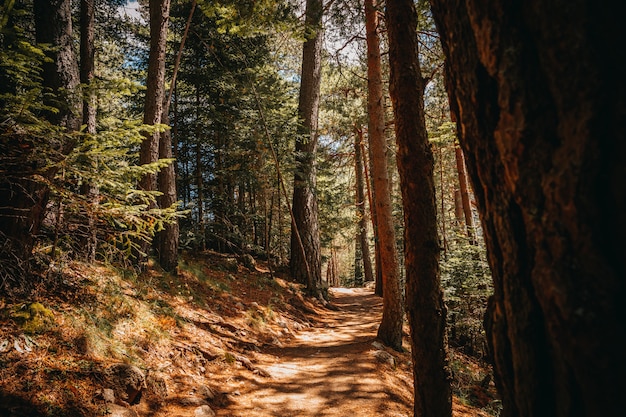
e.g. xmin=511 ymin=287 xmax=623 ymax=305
xmin=290 ymin=0 xmax=323 ymax=294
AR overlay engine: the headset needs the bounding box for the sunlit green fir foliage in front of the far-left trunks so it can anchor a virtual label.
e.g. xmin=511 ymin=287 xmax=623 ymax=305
xmin=0 ymin=2 xmax=178 ymax=289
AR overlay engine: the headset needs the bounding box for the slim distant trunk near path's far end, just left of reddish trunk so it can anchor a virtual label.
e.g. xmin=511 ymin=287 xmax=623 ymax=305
xmin=354 ymin=127 xmax=374 ymax=282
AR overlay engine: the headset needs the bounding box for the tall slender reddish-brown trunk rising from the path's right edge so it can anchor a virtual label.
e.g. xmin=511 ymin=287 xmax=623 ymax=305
xmin=365 ymin=0 xmax=403 ymax=350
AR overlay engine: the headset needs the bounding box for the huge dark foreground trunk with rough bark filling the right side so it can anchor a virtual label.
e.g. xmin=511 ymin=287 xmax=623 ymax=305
xmin=431 ymin=0 xmax=626 ymax=417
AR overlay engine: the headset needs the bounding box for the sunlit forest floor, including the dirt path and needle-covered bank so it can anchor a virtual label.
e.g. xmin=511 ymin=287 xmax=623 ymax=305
xmin=0 ymin=253 xmax=497 ymax=417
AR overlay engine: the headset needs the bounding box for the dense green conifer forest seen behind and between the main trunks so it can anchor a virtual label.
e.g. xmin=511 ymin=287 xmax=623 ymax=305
xmin=2 ymin=2 xmax=490 ymax=355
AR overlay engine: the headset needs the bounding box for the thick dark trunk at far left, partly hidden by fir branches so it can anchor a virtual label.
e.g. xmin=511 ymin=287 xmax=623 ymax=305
xmin=0 ymin=0 xmax=81 ymax=283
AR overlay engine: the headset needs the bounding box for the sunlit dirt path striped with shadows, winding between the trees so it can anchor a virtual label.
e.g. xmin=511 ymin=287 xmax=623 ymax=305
xmin=216 ymin=288 xmax=412 ymax=417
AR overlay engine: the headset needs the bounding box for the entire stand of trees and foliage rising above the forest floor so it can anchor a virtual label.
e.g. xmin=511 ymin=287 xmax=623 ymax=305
xmin=0 ymin=0 xmax=626 ymax=416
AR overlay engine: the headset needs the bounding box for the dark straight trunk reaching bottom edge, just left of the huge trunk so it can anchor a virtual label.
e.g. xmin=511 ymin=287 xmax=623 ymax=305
xmin=387 ymin=0 xmax=452 ymax=417
